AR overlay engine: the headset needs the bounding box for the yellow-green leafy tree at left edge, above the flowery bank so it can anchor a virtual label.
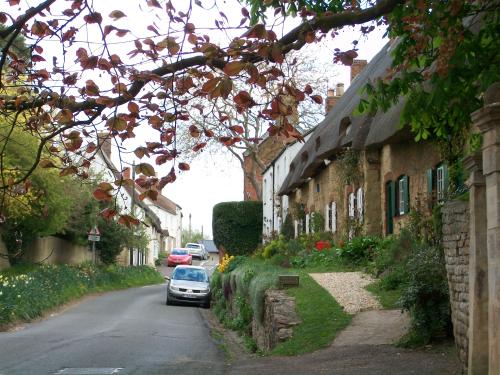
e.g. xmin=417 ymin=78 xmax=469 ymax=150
xmin=0 ymin=123 xmax=86 ymax=263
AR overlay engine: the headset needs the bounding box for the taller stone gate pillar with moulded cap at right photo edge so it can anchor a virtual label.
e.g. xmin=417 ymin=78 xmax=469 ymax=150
xmin=472 ymin=82 xmax=500 ymax=375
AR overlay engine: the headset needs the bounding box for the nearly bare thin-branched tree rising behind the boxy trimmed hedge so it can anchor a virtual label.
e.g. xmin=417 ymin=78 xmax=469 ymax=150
xmin=180 ymin=51 xmax=335 ymax=200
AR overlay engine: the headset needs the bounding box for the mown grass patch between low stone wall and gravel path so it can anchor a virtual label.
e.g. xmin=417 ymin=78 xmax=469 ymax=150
xmin=271 ymin=271 xmax=351 ymax=355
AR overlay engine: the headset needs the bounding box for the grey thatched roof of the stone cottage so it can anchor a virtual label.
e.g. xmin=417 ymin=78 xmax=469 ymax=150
xmin=278 ymin=42 xmax=411 ymax=195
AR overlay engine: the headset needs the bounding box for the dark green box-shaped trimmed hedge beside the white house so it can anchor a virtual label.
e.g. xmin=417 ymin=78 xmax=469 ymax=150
xmin=212 ymin=201 xmax=262 ymax=255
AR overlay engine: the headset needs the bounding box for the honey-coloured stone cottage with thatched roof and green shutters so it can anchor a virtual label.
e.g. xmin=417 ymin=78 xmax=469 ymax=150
xmin=278 ymin=43 xmax=448 ymax=239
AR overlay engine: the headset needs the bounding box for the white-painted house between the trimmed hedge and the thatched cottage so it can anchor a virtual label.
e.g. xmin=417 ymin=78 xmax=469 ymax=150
xmin=262 ymin=131 xmax=312 ymax=239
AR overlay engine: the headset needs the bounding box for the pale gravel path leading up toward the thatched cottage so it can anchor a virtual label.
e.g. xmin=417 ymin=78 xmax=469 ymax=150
xmin=311 ymin=272 xmax=380 ymax=314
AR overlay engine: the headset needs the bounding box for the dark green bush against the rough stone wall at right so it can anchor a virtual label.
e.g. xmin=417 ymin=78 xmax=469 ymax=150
xmin=401 ymin=246 xmax=452 ymax=345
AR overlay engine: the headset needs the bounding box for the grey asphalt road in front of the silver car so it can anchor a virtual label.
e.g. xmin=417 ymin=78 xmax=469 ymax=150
xmin=0 ymin=260 xmax=225 ymax=375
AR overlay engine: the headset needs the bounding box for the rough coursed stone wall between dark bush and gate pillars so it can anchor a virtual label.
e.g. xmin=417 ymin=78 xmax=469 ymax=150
xmin=442 ymin=201 xmax=470 ymax=369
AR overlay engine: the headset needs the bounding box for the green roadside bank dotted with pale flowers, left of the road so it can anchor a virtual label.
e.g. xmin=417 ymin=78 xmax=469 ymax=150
xmin=0 ymin=264 xmax=163 ymax=325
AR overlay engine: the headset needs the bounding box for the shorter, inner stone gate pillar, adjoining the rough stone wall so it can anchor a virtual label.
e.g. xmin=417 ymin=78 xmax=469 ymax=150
xmin=464 ymin=153 xmax=489 ymax=375
